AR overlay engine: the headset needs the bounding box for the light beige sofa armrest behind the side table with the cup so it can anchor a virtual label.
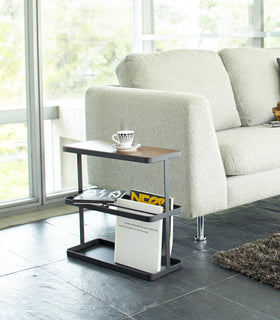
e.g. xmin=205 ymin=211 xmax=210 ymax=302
xmin=86 ymin=86 xmax=227 ymax=217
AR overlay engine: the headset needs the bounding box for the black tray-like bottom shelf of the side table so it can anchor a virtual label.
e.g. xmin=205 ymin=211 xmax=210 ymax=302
xmin=67 ymin=239 xmax=182 ymax=280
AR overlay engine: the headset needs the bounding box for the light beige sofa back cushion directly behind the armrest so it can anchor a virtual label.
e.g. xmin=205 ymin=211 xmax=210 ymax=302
xmin=116 ymin=49 xmax=241 ymax=130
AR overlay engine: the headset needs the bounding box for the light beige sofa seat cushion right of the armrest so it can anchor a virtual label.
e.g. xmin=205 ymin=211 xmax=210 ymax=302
xmin=217 ymin=125 xmax=280 ymax=176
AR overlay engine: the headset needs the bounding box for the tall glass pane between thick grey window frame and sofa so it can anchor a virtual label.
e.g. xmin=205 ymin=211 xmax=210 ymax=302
xmin=42 ymin=0 xmax=132 ymax=194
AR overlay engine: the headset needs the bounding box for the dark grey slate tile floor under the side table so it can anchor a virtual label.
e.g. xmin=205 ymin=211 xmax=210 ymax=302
xmin=0 ymin=197 xmax=280 ymax=320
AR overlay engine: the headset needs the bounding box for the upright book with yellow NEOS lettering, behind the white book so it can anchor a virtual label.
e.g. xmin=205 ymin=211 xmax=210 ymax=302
xmin=130 ymin=189 xmax=174 ymax=255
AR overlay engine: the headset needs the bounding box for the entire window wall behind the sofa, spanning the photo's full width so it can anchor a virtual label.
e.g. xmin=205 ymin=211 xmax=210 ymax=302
xmin=0 ymin=0 xmax=280 ymax=215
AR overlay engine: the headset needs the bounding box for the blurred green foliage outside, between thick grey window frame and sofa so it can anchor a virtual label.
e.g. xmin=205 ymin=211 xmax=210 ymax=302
xmin=42 ymin=0 xmax=132 ymax=101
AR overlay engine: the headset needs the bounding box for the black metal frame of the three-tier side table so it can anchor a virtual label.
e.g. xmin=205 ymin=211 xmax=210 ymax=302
xmin=63 ymin=144 xmax=182 ymax=280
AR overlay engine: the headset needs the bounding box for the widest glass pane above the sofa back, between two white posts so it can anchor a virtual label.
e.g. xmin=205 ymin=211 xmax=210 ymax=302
xmin=154 ymin=0 xmax=248 ymax=51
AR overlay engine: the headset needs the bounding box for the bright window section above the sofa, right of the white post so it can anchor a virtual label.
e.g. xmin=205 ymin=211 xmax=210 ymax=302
xmin=138 ymin=0 xmax=280 ymax=52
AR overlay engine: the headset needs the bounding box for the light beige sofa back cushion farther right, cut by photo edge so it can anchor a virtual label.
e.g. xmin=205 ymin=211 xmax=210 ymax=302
xmin=219 ymin=48 xmax=280 ymax=126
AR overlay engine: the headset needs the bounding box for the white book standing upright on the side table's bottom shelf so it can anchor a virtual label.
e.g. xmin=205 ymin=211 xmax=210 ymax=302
xmin=114 ymin=199 xmax=163 ymax=273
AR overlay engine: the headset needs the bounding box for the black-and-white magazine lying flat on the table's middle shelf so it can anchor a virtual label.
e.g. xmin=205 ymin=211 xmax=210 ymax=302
xmin=73 ymin=188 xmax=126 ymax=204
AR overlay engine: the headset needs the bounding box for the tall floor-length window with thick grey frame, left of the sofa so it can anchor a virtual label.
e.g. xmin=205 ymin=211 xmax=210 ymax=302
xmin=0 ymin=0 xmax=133 ymax=215
